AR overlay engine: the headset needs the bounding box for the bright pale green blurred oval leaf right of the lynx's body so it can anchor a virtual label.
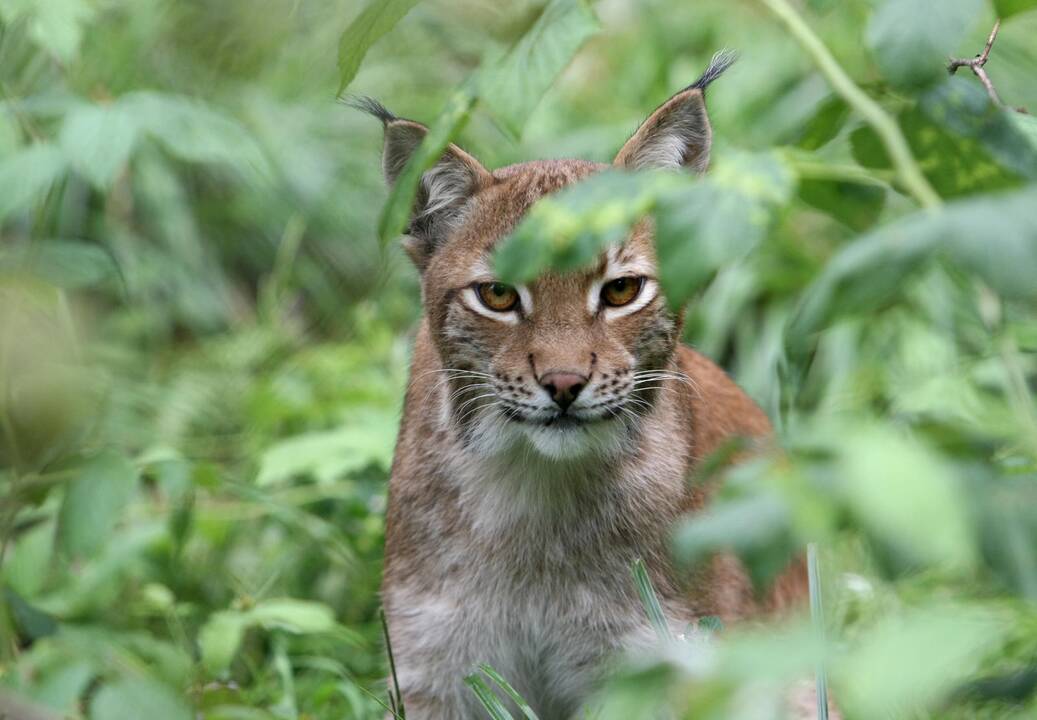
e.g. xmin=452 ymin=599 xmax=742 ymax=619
xmin=839 ymin=430 xmax=975 ymax=570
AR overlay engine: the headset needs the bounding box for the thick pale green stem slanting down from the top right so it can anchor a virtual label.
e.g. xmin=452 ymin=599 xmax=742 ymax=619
xmin=760 ymin=0 xmax=943 ymax=207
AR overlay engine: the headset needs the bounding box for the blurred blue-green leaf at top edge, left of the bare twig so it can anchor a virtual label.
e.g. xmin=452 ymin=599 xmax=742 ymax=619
xmin=867 ymin=0 xmax=983 ymax=87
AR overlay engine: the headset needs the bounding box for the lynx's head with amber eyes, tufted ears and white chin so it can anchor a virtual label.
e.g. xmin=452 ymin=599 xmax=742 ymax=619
xmin=357 ymin=54 xmax=733 ymax=460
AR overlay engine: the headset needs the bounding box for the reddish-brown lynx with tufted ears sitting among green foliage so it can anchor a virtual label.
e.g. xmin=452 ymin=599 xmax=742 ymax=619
xmin=358 ymin=56 xmax=806 ymax=720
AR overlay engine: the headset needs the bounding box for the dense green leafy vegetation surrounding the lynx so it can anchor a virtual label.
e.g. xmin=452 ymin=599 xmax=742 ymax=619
xmin=0 ymin=0 xmax=1037 ymax=720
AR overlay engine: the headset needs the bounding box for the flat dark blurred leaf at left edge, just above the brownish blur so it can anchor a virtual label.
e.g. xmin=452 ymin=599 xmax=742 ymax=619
xmin=0 ymin=240 xmax=118 ymax=289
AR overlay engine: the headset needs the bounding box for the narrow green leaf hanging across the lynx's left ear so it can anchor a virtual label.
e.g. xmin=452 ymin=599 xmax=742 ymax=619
xmin=379 ymin=84 xmax=476 ymax=243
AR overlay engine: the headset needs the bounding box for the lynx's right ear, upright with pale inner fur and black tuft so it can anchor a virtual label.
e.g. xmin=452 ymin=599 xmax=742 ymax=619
xmin=613 ymin=51 xmax=736 ymax=172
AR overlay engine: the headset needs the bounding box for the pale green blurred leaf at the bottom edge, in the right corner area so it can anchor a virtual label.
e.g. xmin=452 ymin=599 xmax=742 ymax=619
xmin=834 ymin=606 xmax=1005 ymax=718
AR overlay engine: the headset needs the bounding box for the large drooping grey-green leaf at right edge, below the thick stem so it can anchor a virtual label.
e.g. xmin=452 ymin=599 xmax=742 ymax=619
xmin=788 ymin=187 xmax=1037 ymax=345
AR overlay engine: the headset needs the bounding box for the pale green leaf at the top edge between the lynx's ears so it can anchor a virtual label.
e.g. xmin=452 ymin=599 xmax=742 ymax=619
xmin=479 ymin=0 xmax=599 ymax=137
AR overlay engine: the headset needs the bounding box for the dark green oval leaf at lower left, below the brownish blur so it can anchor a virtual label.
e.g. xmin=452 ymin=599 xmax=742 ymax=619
xmin=58 ymin=450 xmax=137 ymax=557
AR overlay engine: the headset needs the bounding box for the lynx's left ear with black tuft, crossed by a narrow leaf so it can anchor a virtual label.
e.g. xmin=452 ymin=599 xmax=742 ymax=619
xmin=351 ymin=98 xmax=493 ymax=270
